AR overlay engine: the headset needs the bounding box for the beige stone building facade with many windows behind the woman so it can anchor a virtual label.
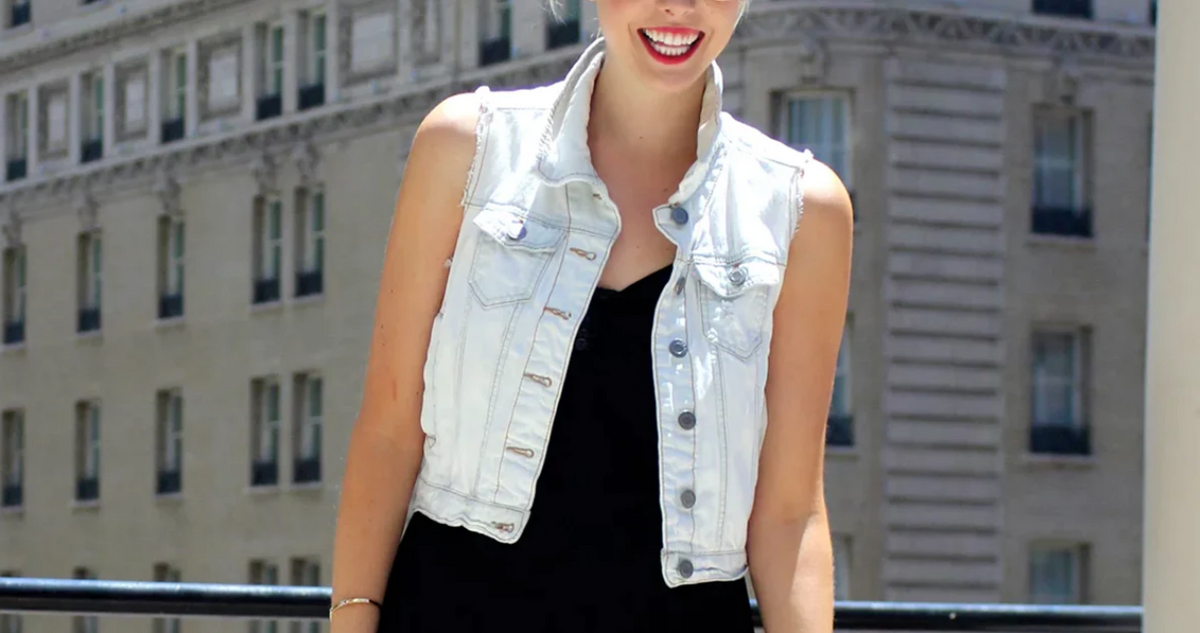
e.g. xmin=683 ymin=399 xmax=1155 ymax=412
xmin=0 ymin=0 xmax=1154 ymax=633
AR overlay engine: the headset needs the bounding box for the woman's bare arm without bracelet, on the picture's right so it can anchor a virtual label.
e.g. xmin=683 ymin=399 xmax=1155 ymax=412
xmin=746 ymin=161 xmax=854 ymax=633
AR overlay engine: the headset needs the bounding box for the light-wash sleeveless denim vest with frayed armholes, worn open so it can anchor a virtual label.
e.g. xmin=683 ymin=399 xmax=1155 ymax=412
xmin=409 ymin=40 xmax=811 ymax=586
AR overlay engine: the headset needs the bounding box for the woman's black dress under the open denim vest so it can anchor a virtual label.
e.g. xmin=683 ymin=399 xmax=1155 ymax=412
xmin=378 ymin=266 xmax=754 ymax=633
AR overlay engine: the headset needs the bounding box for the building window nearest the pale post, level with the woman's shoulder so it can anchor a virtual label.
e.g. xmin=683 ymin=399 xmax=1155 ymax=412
xmin=1032 ymin=108 xmax=1092 ymax=237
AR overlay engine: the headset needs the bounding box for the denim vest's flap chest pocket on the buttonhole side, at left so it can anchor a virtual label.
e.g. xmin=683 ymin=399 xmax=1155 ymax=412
xmin=470 ymin=207 xmax=566 ymax=307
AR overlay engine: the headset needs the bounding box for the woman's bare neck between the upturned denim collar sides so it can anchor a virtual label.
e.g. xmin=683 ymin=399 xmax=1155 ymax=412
xmin=588 ymin=59 xmax=707 ymax=162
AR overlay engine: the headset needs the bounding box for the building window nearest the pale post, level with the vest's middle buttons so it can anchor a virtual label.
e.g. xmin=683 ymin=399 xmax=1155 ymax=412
xmin=1030 ymin=330 xmax=1091 ymax=454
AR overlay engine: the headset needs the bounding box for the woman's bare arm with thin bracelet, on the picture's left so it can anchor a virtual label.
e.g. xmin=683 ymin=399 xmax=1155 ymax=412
xmin=330 ymin=94 xmax=479 ymax=633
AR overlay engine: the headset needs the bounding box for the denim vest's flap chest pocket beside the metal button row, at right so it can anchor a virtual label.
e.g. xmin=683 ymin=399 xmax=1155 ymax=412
xmin=695 ymin=254 xmax=782 ymax=360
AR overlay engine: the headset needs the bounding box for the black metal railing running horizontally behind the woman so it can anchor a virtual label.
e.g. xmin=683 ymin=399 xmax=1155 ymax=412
xmin=0 ymin=578 xmax=1142 ymax=633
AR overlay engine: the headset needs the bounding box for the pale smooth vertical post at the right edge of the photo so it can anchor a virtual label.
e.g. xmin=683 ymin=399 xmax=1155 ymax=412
xmin=1142 ymin=0 xmax=1200 ymax=633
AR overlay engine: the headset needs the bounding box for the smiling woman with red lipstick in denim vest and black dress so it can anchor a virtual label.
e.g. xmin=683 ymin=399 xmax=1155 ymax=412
xmin=330 ymin=0 xmax=852 ymax=633
